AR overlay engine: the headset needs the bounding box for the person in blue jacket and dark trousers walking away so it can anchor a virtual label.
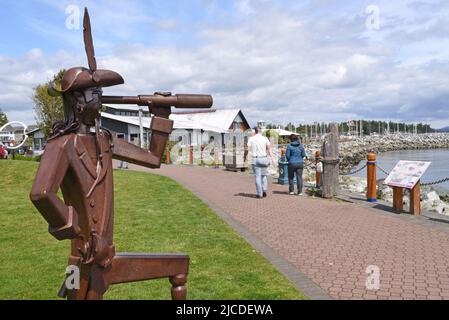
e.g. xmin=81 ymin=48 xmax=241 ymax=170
xmin=285 ymin=135 xmax=307 ymax=196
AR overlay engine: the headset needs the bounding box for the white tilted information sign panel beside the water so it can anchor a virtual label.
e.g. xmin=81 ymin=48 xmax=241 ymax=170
xmin=385 ymin=160 xmax=431 ymax=189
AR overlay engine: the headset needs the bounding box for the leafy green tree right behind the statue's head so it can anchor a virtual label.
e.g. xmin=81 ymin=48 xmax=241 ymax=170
xmin=33 ymin=70 xmax=65 ymax=137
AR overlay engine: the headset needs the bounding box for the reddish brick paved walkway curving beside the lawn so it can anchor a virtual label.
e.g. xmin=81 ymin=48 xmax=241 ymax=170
xmin=123 ymin=162 xmax=449 ymax=299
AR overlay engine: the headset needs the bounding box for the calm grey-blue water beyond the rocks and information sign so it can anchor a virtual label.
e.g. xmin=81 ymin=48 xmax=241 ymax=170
xmin=355 ymin=149 xmax=449 ymax=189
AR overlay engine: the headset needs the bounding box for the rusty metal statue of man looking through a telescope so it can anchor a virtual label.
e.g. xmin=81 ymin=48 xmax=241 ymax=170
xmin=30 ymin=8 xmax=212 ymax=299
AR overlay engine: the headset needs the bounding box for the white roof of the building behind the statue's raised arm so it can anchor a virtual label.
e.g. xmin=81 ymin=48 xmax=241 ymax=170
xmin=101 ymin=106 xmax=246 ymax=133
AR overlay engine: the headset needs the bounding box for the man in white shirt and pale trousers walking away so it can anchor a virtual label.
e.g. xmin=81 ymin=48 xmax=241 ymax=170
xmin=245 ymin=127 xmax=274 ymax=199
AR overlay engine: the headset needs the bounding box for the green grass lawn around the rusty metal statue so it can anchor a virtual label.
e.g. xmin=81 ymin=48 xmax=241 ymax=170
xmin=0 ymin=160 xmax=305 ymax=299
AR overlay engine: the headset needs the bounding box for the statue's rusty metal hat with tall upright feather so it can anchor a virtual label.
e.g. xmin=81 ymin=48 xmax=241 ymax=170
xmin=48 ymin=8 xmax=125 ymax=95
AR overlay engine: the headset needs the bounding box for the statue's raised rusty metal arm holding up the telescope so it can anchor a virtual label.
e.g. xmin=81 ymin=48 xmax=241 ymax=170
xmin=113 ymin=116 xmax=173 ymax=168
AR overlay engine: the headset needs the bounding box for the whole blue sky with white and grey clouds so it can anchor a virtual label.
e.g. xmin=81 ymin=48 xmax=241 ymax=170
xmin=0 ymin=0 xmax=449 ymax=128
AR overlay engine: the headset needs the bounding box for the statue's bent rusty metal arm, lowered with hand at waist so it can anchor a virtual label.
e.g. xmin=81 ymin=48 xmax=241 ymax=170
xmin=30 ymin=141 xmax=80 ymax=240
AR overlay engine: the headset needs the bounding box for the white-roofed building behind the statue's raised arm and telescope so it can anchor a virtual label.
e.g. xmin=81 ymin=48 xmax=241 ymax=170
xmin=101 ymin=106 xmax=250 ymax=169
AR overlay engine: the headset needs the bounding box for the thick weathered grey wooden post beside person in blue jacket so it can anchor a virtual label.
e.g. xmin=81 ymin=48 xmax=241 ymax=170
xmin=321 ymin=123 xmax=340 ymax=198
